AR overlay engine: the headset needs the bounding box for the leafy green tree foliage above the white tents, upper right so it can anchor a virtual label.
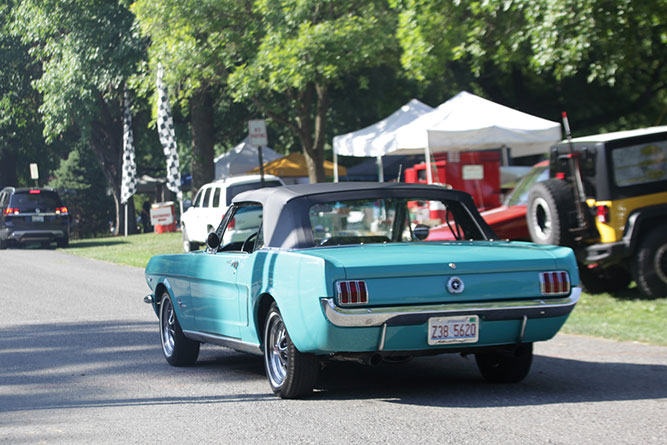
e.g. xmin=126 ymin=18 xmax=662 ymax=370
xmin=392 ymin=0 xmax=667 ymax=132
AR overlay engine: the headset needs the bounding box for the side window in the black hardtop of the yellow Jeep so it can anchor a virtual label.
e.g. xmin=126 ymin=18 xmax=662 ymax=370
xmin=611 ymin=141 xmax=667 ymax=187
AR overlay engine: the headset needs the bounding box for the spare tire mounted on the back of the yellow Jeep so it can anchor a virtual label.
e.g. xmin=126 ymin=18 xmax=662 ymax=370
xmin=526 ymin=179 xmax=575 ymax=246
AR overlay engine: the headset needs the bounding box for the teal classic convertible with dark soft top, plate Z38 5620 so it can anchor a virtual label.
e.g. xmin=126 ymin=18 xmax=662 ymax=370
xmin=144 ymin=183 xmax=581 ymax=398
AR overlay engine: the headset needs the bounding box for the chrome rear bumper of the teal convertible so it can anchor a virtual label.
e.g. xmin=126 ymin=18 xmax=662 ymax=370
xmin=320 ymin=287 xmax=581 ymax=327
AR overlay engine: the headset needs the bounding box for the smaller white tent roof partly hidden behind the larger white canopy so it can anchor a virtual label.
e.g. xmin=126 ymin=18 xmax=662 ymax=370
xmin=333 ymin=99 xmax=433 ymax=156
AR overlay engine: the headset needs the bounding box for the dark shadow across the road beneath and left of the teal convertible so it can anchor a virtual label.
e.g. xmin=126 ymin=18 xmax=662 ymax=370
xmin=0 ymin=321 xmax=667 ymax=412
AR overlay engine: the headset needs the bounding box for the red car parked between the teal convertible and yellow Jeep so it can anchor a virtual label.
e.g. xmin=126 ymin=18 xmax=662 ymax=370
xmin=427 ymin=161 xmax=549 ymax=241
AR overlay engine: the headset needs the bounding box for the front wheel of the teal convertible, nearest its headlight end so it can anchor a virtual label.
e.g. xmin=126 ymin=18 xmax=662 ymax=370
xmin=160 ymin=292 xmax=200 ymax=366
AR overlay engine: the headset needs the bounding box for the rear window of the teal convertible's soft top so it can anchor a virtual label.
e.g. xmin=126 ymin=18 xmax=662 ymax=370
xmin=309 ymin=197 xmax=484 ymax=246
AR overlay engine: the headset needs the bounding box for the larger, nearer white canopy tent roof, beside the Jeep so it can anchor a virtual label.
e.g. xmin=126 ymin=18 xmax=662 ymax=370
xmin=390 ymin=91 xmax=561 ymax=157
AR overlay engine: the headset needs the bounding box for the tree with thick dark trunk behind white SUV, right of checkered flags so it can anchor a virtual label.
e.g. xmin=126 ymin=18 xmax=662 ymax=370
xmin=132 ymin=0 xmax=250 ymax=193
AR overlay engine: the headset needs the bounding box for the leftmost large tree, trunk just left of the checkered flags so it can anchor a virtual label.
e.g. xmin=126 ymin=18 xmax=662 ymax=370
xmin=14 ymin=0 xmax=145 ymax=234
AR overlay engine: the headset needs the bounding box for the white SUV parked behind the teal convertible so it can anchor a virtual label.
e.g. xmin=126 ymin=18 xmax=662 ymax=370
xmin=181 ymin=175 xmax=285 ymax=252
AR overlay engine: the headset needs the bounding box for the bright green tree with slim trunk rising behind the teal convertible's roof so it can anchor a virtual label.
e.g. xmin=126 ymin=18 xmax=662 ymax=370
xmin=229 ymin=0 xmax=398 ymax=182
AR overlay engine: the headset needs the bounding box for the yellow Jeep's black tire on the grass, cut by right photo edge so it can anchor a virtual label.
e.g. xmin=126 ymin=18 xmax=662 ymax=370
xmin=633 ymin=225 xmax=667 ymax=298
